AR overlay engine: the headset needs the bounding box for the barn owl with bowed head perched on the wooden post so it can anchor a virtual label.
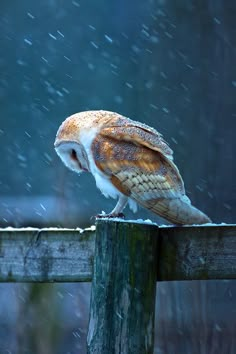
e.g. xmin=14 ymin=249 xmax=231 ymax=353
xmin=54 ymin=110 xmax=210 ymax=225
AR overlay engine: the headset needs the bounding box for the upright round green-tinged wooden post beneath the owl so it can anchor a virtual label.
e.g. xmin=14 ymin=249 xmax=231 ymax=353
xmin=87 ymin=219 xmax=158 ymax=354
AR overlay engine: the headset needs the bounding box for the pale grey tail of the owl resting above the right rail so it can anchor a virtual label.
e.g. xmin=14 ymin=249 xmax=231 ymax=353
xmin=148 ymin=196 xmax=211 ymax=225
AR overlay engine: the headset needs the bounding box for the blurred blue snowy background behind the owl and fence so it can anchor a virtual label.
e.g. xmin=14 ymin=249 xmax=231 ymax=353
xmin=0 ymin=0 xmax=236 ymax=354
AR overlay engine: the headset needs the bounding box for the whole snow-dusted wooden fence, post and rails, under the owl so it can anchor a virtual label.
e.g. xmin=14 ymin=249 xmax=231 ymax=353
xmin=0 ymin=219 xmax=236 ymax=354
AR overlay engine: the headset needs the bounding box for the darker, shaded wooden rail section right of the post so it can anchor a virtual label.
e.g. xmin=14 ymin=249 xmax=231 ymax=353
xmin=157 ymin=225 xmax=236 ymax=280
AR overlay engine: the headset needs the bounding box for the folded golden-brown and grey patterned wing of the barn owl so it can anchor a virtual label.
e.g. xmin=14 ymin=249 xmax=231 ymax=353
xmin=92 ymin=127 xmax=193 ymax=223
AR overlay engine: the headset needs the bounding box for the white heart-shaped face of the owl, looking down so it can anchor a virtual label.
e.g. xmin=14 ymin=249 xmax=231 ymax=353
xmin=55 ymin=141 xmax=89 ymax=173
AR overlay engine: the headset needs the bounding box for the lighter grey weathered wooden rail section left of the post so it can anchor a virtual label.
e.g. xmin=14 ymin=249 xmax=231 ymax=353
xmin=0 ymin=228 xmax=95 ymax=282
